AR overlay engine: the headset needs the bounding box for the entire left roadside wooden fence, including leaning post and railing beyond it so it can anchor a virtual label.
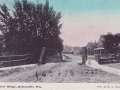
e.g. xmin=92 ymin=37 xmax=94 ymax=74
xmin=0 ymin=47 xmax=62 ymax=68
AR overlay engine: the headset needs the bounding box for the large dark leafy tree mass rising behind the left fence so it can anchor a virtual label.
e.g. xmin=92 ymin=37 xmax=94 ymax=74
xmin=0 ymin=0 xmax=63 ymax=54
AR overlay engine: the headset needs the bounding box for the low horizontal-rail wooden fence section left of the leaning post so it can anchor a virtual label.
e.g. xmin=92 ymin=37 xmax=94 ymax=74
xmin=0 ymin=54 xmax=37 ymax=67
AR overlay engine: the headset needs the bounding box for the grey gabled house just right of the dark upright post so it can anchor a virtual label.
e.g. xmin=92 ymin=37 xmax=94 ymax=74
xmin=86 ymin=41 xmax=98 ymax=55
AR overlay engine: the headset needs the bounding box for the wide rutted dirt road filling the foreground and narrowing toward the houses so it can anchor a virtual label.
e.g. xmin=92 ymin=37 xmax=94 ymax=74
xmin=0 ymin=55 xmax=120 ymax=83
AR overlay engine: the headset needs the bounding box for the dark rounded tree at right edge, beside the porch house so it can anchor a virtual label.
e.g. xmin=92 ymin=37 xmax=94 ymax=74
xmin=103 ymin=33 xmax=120 ymax=54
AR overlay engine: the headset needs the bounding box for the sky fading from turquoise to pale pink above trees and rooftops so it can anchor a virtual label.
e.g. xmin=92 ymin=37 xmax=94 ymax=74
xmin=0 ymin=0 xmax=120 ymax=47
